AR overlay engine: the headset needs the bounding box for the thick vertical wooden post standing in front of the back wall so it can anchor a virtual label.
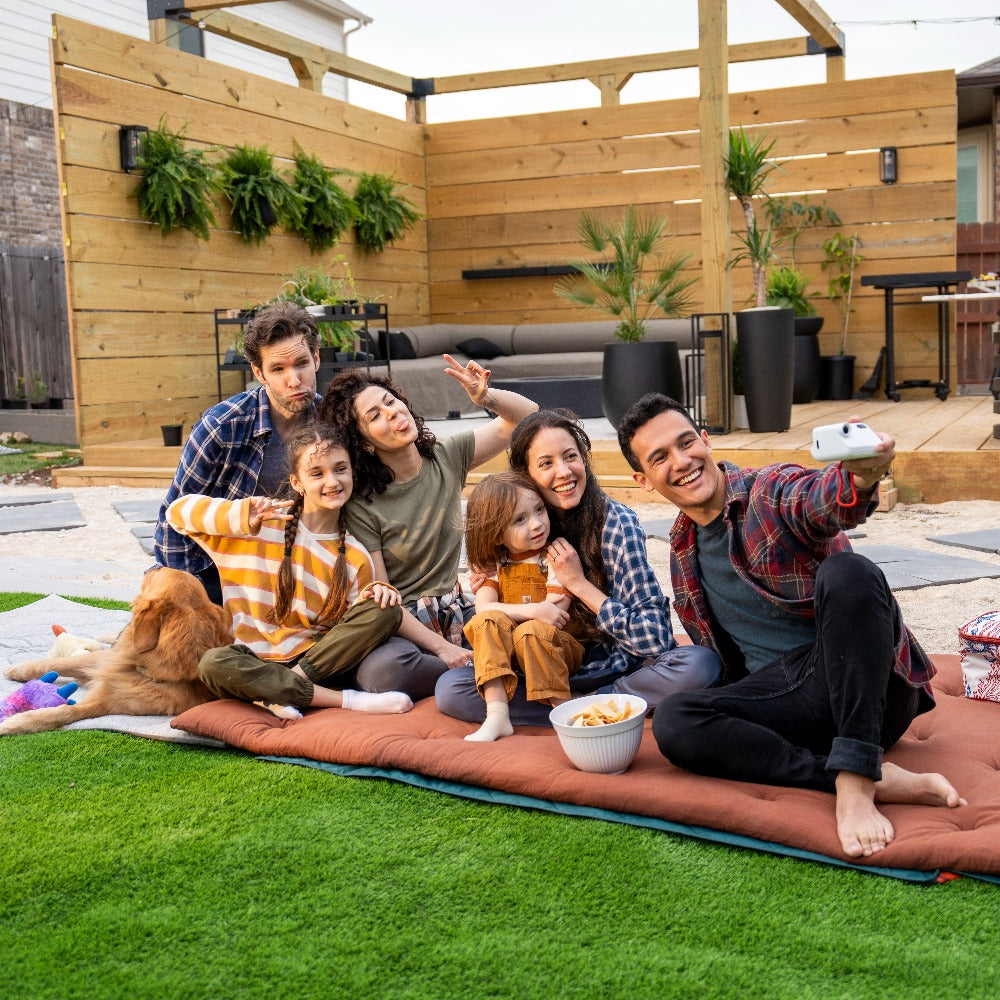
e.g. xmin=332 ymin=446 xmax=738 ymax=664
xmin=698 ymin=0 xmax=733 ymax=424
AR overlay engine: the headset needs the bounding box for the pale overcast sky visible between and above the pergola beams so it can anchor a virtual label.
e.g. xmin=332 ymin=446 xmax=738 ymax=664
xmin=348 ymin=0 xmax=1000 ymax=121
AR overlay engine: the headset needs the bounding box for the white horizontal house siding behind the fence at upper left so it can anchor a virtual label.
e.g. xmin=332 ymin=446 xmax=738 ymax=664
xmin=0 ymin=0 xmax=358 ymax=108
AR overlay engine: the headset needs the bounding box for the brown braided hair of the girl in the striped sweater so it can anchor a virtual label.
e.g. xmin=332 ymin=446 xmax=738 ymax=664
xmin=272 ymin=423 xmax=350 ymax=625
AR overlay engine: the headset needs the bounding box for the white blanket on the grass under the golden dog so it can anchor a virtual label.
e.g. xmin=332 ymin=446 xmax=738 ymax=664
xmin=0 ymin=594 xmax=225 ymax=746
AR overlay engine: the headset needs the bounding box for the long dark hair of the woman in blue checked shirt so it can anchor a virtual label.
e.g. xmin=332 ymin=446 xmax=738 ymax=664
xmin=510 ymin=408 xmax=609 ymax=638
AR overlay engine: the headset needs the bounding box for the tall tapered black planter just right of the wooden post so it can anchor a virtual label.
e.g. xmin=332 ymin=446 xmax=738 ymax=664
xmin=736 ymin=308 xmax=795 ymax=434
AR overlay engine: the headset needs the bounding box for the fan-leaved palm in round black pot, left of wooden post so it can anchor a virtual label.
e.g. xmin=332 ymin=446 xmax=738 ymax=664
xmin=555 ymin=205 xmax=697 ymax=425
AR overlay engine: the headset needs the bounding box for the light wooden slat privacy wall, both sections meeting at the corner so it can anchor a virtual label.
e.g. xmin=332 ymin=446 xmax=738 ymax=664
xmin=53 ymin=16 xmax=955 ymax=445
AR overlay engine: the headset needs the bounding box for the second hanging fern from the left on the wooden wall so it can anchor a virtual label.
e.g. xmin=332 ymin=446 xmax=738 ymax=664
xmin=219 ymin=146 xmax=302 ymax=245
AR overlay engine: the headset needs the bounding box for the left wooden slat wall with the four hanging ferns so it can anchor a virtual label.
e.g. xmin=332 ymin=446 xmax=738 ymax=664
xmin=52 ymin=16 xmax=428 ymax=447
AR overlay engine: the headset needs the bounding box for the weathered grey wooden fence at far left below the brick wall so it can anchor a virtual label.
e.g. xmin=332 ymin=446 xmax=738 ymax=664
xmin=0 ymin=246 xmax=73 ymax=403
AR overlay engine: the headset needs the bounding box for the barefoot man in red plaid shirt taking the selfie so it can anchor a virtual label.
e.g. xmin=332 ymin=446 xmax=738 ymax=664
xmin=618 ymin=394 xmax=965 ymax=857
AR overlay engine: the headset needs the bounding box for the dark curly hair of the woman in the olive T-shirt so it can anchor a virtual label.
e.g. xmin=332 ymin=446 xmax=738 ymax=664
xmin=319 ymin=368 xmax=437 ymax=500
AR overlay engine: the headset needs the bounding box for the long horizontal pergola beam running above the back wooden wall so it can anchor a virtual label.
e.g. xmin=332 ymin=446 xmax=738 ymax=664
xmin=427 ymin=38 xmax=816 ymax=94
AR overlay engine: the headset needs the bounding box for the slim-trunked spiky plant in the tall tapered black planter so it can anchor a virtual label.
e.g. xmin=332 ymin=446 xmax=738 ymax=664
xmin=725 ymin=126 xmax=795 ymax=433
